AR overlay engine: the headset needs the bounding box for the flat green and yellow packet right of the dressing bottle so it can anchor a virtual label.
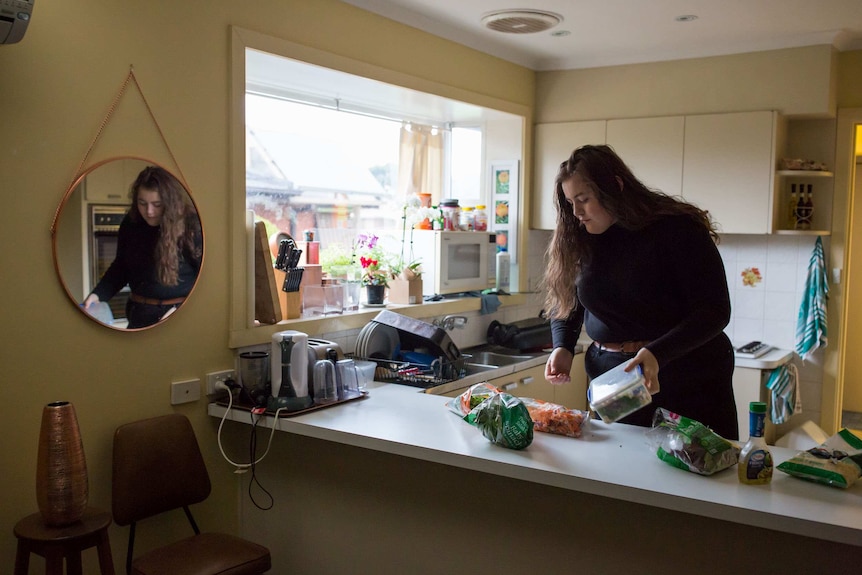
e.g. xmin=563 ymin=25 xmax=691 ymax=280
xmin=777 ymin=428 xmax=862 ymax=489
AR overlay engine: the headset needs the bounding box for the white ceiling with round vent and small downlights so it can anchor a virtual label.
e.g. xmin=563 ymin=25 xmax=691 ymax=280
xmin=344 ymin=0 xmax=862 ymax=70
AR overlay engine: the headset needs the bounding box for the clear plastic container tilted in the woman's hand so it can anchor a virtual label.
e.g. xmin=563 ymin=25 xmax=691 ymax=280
xmin=589 ymin=361 xmax=652 ymax=423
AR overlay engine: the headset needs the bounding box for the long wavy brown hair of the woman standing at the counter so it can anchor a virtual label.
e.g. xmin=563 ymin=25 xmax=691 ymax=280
xmin=543 ymin=145 xmax=719 ymax=319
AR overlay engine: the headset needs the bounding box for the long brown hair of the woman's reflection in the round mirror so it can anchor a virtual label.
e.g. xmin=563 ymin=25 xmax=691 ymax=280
xmin=131 ymin=166 xmax=201 ymax=286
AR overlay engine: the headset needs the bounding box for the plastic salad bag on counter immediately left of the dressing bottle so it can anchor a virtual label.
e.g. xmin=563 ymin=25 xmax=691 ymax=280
xmin=646 ymin=408 xmax=739 ymax=475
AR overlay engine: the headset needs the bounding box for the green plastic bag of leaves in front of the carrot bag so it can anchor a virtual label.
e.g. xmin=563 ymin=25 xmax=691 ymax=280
xmin=472 ymin=393 xmax=533 ymax=449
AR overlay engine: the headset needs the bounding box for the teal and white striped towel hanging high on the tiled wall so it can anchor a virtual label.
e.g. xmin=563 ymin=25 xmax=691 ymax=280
xmin=796 ymin=236 xmax=829 ymax=360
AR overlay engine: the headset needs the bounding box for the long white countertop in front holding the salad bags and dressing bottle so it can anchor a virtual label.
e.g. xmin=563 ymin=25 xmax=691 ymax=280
xmin=208 ymin=383 xmax=862 ymax=546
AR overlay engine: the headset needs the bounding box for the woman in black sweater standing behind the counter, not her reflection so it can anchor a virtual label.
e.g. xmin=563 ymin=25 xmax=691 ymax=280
xmin=545 ymin=146 xmax=738 ymax=439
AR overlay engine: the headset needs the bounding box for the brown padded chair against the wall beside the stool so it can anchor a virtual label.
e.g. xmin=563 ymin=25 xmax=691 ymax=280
xmin=112 ymin=414 xmax=272 ymax=575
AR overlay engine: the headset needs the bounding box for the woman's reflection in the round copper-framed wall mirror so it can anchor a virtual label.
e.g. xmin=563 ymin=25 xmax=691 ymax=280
xmin=84 ymin=166 xmax=203 ymax=329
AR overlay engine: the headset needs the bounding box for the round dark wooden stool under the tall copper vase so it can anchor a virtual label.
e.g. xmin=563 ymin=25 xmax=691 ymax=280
xmin=14 ymin=507 xmax=114 ymax=575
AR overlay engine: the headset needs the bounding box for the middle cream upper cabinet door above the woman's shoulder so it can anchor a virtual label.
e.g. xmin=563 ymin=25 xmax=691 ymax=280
xmin=607 ymin=116 xmax=685 ymax=196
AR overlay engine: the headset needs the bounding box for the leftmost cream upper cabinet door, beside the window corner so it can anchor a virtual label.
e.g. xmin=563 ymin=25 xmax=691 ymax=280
xmin=531 ymin=120 xmax=608 ymax=230
